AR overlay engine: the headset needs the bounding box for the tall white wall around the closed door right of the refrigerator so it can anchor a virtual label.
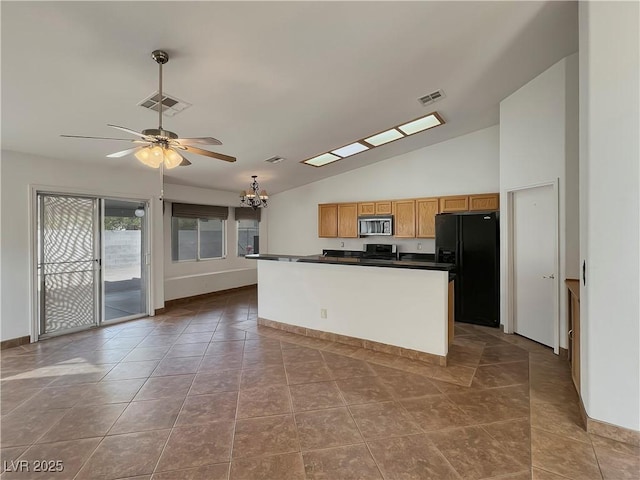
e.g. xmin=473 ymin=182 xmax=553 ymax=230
xmin=500 ymin=54 xmax=579 ymax=348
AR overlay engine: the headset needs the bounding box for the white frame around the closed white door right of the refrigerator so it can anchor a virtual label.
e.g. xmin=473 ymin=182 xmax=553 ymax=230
xmin=504 ymin=178 xmax=560 ymax=354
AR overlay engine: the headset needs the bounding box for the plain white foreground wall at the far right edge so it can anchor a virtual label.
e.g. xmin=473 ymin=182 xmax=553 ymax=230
xmin=579 ymin=2 xmax=640 ymax=430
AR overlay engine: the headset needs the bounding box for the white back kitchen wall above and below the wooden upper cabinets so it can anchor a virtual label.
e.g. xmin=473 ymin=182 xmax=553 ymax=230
xmin=268 ymin=125 xmax=499 ymax=255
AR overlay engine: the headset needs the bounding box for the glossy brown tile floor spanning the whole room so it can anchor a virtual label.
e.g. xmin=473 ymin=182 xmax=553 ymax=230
xmin=0 ymin=290 xmax=640 ymax=480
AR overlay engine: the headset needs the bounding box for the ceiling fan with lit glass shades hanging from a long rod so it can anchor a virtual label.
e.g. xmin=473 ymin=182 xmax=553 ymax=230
xmin=60 ymin=50 xmax=236 ymax=169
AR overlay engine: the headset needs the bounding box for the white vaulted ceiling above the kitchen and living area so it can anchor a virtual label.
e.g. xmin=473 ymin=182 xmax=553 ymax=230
xmin=1 ymin=1 xmax=578 ymax=193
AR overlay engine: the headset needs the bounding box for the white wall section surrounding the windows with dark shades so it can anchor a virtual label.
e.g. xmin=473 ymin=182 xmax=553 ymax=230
xmin=164 ymin=184 xmax=268 ymax=300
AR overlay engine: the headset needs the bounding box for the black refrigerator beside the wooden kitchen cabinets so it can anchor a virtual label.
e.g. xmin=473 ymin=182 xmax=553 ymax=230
xmin=436 ymin=212 xmax=500 ymax=327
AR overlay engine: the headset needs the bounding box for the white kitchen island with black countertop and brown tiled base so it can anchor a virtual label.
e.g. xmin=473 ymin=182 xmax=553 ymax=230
xmin=247 ymin=254 xmax=454 ymax=365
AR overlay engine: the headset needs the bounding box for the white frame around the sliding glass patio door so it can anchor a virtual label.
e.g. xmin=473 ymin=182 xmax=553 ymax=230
xmin=27 ymin=184 xmax=155 ymax=343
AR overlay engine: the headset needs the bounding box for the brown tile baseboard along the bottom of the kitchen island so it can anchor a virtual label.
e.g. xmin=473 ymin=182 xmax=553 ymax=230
xmin=258 ymin=317 xmax=447 ymax=367
